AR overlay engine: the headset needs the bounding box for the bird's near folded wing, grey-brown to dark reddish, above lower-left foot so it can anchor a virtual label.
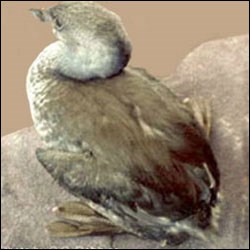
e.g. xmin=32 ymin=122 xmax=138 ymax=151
xmin=37 ymin=127 xmax=217 ymax=219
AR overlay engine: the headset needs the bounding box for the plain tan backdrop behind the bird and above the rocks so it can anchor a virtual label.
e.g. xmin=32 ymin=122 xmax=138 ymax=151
xmin=1 ymin=1 xmax=249 ymax=135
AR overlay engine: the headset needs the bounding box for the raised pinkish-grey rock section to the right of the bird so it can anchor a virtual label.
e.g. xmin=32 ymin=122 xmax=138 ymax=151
xmin=165 ymin=35 xmax=249 ymax=249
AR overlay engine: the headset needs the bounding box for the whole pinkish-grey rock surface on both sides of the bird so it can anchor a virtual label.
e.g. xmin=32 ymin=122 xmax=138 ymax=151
xmin=1 ymin=35 xmax=249 ymax=249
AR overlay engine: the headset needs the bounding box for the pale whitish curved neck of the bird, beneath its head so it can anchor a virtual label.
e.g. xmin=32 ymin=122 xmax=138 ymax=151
xmin=29 ymin=41 xmax=120 ymax=81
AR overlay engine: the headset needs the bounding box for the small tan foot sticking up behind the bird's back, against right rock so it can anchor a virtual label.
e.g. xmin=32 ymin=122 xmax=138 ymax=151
xmin=183 ymin=97 xmax=212 ymax=139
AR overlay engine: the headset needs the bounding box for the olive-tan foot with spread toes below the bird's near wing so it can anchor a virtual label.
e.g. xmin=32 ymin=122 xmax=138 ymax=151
xmin=47 ymin=201 xmax=123 ymax=238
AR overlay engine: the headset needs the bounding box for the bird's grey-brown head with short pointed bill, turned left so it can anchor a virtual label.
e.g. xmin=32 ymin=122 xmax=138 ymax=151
xmin=31 ymin=1 xmax=132 ymax=78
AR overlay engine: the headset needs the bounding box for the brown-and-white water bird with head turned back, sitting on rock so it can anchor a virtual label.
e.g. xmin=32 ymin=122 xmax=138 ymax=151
xmin=27 ymin=1 xmax=220 ymax=245
